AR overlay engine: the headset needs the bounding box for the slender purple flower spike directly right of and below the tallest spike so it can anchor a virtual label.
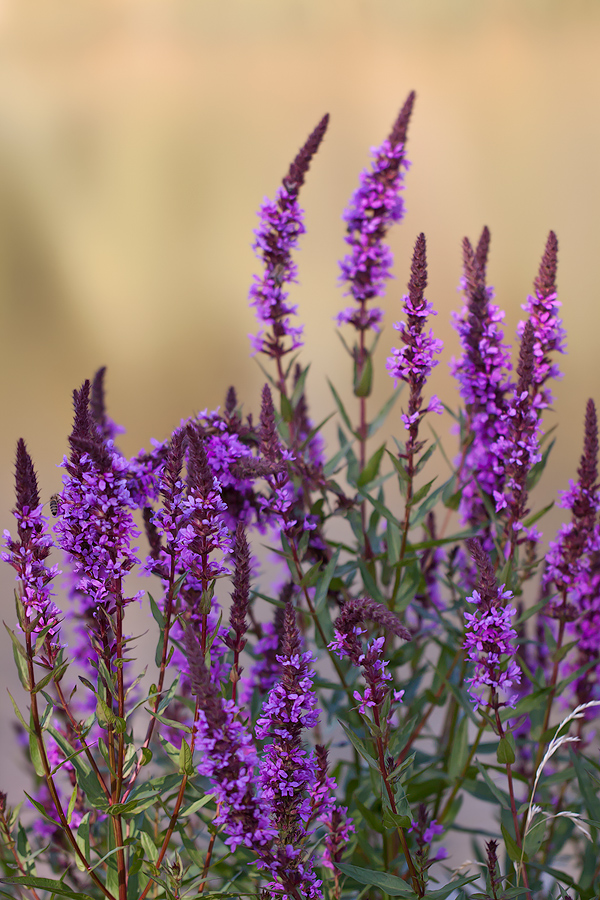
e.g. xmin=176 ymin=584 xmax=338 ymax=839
xmin=386 ymin=234 xmax=444 ymax=442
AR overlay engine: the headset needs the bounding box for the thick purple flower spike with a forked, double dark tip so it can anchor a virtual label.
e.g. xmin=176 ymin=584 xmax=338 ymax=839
xmin=452 ymin=228 xmax=512 ymax=532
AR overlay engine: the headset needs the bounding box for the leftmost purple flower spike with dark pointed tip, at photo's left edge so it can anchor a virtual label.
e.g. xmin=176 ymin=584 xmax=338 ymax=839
xmin=2 ymin=438 xmax=60 ymax=643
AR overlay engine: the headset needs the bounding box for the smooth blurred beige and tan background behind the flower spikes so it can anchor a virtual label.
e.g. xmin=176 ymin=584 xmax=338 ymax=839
xmin=0 ymin=0 xmax=600 ymax=801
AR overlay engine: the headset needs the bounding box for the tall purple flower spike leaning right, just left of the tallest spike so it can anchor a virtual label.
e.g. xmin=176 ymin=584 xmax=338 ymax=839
xmin=250 ymin=115 xmax=329 ymax=360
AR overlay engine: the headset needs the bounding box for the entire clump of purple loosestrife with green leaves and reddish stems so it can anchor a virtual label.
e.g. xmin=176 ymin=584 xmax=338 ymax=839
xmin=0 ymin=94 xmax=600 ymax=900
